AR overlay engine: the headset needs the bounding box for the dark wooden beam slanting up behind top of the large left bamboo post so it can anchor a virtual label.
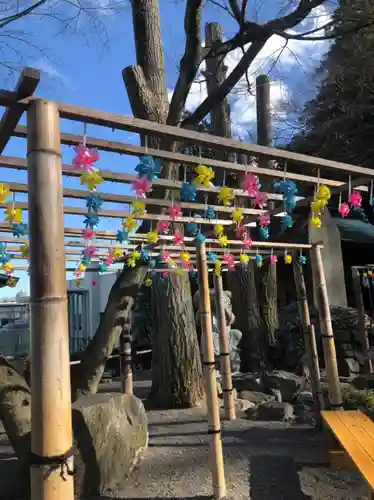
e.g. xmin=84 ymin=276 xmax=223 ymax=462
xmin=0 ymin=68 xmax=40 ymax=154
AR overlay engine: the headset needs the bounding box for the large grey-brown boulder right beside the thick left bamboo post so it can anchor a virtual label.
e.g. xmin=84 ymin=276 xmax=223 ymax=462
xmin=72 ymin=394 xmax=148 ymax=496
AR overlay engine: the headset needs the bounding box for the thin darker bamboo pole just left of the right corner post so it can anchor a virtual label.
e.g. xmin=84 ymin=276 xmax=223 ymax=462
xmin=293 ymin=260 xmax=325 ymax=427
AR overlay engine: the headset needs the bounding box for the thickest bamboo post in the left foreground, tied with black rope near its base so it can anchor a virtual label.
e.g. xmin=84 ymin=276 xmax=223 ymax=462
xmin=27 ymin=99 xmax=74 ymax=500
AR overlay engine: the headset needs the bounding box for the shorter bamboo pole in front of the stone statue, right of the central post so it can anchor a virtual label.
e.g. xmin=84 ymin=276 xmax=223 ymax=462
xmin=214 ymin=275 xmax=236 ymax=420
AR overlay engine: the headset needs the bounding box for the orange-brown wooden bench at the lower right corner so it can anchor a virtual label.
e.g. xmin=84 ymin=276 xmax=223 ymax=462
xmin=321 ymin=411 xmax=374 ymax=500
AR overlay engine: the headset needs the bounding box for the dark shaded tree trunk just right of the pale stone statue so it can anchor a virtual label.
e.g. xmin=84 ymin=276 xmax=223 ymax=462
xmin=227 ymin=260 xmax=265 ymax=373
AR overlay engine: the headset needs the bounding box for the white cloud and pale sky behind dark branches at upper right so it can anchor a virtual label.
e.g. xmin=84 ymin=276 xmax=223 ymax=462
xmin=169 ymin=6 xmax=331 ymax=145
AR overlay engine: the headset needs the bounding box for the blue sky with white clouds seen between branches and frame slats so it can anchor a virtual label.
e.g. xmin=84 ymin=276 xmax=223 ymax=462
xmin=0 ymin=0 xmax=328 ymax=297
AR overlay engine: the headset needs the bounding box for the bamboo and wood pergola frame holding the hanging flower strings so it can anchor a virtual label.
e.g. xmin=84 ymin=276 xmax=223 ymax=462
xmin=0 ymin=69 xmax=374 ymax=500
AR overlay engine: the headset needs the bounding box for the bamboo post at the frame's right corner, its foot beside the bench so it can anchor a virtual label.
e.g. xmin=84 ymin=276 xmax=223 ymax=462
xmin=311 ymin=245 xmax=342 ymax=410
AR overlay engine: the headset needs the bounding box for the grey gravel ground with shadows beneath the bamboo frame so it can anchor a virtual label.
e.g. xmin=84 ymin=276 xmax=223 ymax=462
xmin=0 ymin=374 xmax=367 ymax=500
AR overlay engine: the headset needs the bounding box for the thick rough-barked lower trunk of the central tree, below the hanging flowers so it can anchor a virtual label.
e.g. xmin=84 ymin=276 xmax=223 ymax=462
xmin=149 ymin=273 xmax=204 ymax=408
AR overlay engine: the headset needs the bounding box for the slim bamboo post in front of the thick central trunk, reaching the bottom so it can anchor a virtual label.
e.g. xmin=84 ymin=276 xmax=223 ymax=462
xmin=196 ymin=243 xmax=226 ymax=500
